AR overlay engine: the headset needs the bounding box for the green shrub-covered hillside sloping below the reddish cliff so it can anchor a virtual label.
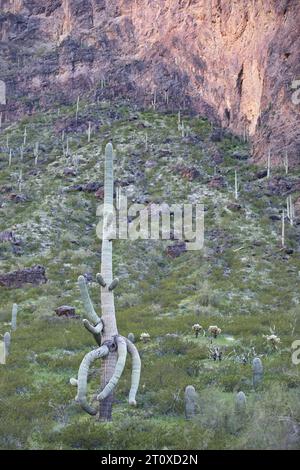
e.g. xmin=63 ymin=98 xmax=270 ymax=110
xmin=0 ymin=100 xmax=300 ymax=449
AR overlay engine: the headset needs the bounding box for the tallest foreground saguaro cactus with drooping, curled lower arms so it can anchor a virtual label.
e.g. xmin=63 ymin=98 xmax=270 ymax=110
xmin=70 ymin=144 xmax=141 ymax=421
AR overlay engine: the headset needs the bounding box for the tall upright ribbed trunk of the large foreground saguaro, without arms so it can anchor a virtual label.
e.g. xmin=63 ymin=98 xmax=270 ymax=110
xmin=99 ymin=144 xmax=118 ymax=421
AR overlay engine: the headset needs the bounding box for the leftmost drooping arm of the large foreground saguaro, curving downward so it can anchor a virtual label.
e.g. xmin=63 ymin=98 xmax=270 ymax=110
xmin=72 ymin=346 xmax=109 ymax=415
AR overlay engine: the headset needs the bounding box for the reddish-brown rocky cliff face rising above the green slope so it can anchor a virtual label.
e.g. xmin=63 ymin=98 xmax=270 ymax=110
xmin=0 ymin=0 xmax=300 ymax=164
